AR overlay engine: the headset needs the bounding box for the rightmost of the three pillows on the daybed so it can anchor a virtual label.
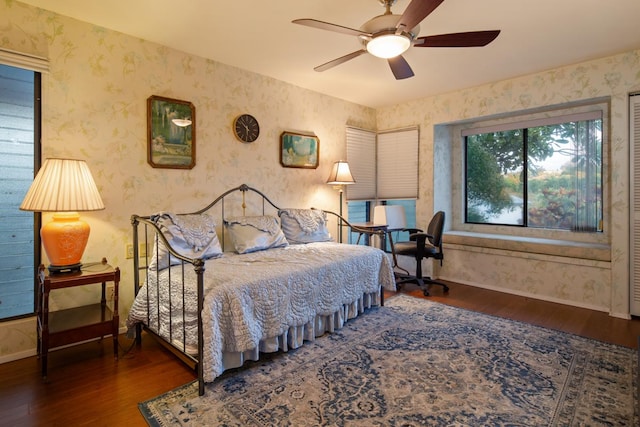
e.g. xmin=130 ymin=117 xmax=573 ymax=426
xmin=278 ymin=209 xmax=333 ymax=244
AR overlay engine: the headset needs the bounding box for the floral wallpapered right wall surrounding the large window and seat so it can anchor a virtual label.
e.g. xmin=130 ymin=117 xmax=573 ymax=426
xmin=376 ymin=51 xmax=640 ymax=318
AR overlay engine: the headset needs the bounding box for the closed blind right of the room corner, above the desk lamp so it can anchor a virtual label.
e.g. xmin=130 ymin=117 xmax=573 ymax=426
xmin=377 ymin=128 xmax=419 ymax=200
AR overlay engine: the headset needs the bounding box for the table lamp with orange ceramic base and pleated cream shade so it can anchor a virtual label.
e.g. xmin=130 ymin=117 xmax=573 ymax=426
xmin=20 ymin=159 xmax=104 ymax=273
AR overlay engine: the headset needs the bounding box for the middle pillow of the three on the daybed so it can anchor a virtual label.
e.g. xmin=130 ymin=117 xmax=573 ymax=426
xmin=224 ymin=215 xmax=289 ymax=254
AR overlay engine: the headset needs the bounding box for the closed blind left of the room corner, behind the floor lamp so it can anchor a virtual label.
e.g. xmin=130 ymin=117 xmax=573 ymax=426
xmin=346 ymin=127 xmax=376 ymax=200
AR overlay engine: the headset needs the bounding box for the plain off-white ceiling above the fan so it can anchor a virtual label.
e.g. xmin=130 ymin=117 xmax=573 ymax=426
xmin=16 ymin=0 xmax=640 ymax=107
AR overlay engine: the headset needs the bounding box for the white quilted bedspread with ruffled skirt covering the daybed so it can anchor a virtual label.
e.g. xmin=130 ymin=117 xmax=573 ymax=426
xmin=127 ymin=242 xmax=395 ymax=381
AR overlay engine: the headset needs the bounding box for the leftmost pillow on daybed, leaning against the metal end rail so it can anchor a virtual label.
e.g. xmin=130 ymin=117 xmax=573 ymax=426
xmin=149 ymin=212 xmax=222 ymax=270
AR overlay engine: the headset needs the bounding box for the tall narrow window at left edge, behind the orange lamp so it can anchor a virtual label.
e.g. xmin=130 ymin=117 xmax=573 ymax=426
xmin=0 ymin=61 xmax=40 ymax=319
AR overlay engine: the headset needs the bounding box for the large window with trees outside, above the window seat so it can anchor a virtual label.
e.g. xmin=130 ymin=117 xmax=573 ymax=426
xmin=462 ymin=110 xmax=603 ymax=232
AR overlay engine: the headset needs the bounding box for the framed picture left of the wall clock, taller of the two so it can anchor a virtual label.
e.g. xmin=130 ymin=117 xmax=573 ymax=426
xmin=147 ymin=95 xmax=196 ymax=169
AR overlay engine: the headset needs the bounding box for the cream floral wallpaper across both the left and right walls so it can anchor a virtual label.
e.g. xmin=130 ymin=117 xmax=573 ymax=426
xmin=0 ymin=0 xmax=640 ymax=362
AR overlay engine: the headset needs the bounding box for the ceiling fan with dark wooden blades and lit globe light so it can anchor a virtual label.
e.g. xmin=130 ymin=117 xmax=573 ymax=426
xmin=292 ymin=0 xmax=500 ymax=80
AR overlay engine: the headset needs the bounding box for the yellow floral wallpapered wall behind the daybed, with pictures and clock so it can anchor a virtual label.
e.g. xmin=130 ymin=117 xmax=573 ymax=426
xmin=0 ymin=0 xmax=375 ymax=361
